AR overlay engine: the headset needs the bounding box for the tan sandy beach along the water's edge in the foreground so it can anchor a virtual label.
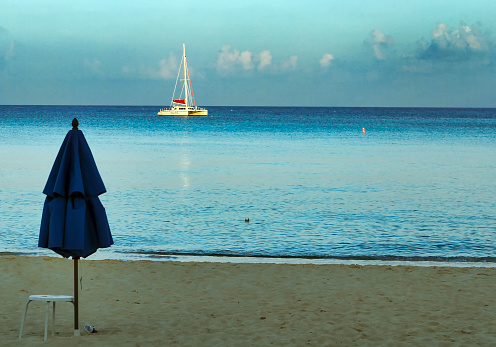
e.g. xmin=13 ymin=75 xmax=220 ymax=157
xmin=0 ymin=256 xmax=496 ymax=346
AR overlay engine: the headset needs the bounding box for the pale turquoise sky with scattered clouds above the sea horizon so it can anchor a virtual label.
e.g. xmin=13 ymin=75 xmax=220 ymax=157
xmin=0 ymin=0 xmax=496 ymax=107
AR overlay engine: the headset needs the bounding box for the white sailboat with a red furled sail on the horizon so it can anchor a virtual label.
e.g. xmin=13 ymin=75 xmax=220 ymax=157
xmin=157 ymin=43 xmax=208 ymax=116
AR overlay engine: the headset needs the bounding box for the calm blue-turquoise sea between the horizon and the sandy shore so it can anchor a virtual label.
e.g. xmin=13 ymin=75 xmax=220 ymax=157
xmin=0 ymin=106 xmax=496 ymax=263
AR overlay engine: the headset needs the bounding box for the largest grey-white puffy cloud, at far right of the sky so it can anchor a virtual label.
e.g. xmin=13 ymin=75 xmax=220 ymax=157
xmin=416 ymin=23 xmax=494 ymax=60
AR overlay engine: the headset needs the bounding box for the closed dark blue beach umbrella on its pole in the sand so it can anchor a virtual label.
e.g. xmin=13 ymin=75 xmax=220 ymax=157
xmin=38 ymin=118 xmax=114 ymax=335
